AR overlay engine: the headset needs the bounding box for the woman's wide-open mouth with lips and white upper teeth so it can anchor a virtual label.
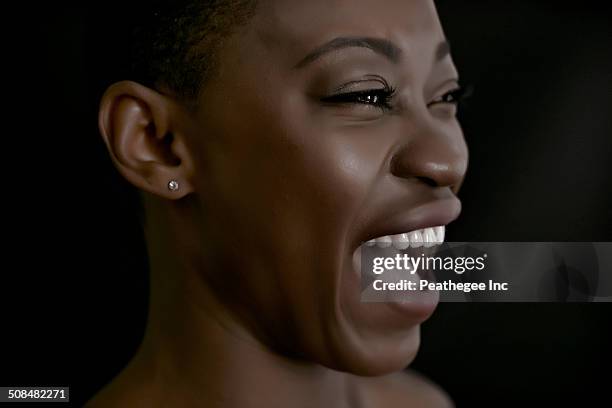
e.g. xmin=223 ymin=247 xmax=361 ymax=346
xmin=350 ymin=196 xmax=461 ymax=323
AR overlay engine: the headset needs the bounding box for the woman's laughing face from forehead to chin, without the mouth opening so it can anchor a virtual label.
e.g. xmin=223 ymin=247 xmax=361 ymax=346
xmin=188 ymin=0 xmax=467 ymax=374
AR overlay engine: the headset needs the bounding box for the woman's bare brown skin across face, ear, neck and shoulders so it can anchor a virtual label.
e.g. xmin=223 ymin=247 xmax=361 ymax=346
xmin=89 ymin=0 xmax=467 ymax=407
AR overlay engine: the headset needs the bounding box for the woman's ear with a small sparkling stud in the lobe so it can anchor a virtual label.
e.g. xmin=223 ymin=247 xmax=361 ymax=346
xmin=98 ymin=81 xmax=193 ymax=199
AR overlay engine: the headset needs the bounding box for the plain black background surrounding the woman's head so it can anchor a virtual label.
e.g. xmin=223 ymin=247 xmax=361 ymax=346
xmin=0 ymin=0 xmax=612 ymax=407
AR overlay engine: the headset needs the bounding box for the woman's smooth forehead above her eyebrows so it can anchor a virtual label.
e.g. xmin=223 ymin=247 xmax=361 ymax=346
xmin=251 ymin=0 xmax=444 ymax=58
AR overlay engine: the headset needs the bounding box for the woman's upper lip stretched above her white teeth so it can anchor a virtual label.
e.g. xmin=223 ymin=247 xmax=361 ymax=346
xmin=356 ymin=195 xmax=461 ymax=246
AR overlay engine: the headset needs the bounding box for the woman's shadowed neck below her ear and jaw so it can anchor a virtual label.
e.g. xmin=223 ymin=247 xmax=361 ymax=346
xmin=117 ymin=199 xmax=352 ymax=408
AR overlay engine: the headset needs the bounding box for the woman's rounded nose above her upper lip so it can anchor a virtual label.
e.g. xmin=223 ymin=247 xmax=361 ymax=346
xmin=390 ymin=121 xmax=468 ymax=191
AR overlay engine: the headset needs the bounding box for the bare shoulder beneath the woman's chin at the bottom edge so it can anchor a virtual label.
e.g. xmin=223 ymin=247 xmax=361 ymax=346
xmin=363 ymin=370 xmax=455 ymax=408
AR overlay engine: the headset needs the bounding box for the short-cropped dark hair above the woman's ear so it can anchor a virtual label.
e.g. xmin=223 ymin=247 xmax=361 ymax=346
xmin=130 ymin=0 xmax=256 ymax=104
